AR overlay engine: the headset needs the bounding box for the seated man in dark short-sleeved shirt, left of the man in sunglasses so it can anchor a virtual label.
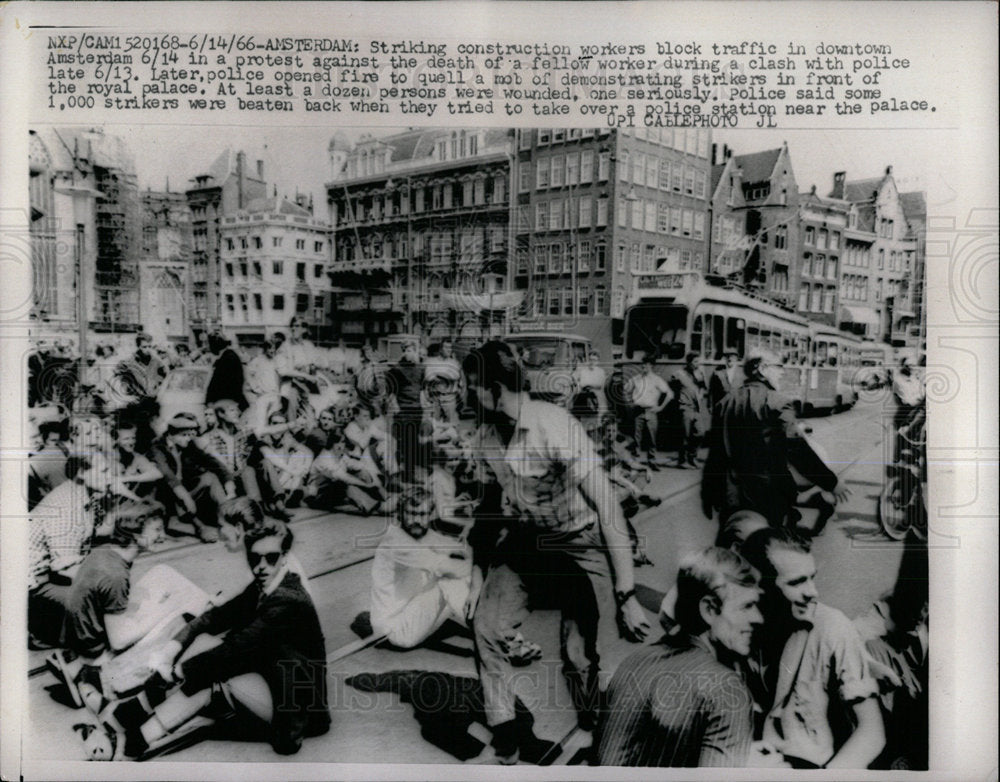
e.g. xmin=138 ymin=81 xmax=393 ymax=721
xmin=47 ymin=501 xmax=163 ymax=707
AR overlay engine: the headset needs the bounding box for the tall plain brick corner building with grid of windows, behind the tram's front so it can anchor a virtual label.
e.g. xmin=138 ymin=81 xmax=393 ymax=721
xmin=511 ymin=128 xmax=711 ymax=358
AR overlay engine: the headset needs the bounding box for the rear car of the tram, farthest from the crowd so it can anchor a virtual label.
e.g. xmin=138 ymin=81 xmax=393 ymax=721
xmin=802 ymin=323 xmax=861 ymax=412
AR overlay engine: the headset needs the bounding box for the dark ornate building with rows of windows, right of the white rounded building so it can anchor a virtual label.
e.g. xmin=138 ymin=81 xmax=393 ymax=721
xmin=327 ymin=129 xmax=514 ymax=344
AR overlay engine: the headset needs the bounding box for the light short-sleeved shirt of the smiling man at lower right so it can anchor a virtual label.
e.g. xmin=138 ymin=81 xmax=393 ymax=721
xmin=764 ymin=603 xmax=878 ymax=765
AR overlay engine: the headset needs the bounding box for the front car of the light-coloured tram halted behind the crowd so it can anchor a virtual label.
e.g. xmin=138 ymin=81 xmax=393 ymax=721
xmin=622 ymin=271 xmax=810 ymax=412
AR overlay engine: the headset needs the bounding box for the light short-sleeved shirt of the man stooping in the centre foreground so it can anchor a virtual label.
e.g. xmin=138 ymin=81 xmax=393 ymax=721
xmin=473 ymin=400 xmax=602 ymax=532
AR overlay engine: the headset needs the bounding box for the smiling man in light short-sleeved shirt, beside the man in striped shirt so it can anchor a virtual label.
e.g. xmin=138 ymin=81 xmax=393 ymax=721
xmin=740 ymin=529 xmax=885 ymax=768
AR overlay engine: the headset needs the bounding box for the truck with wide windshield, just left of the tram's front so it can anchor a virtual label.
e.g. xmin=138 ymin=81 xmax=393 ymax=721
xmin=503 ymin=331 xmax=591 ymax=405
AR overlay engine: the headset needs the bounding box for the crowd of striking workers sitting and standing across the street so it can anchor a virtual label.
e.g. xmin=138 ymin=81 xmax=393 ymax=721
xmin=28 ymin=319 xmax=927 ymax=768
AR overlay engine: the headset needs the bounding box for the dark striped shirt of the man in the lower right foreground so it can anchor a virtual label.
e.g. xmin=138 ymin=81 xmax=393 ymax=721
xmin=598 ymin=638 xmax=753 ymax=767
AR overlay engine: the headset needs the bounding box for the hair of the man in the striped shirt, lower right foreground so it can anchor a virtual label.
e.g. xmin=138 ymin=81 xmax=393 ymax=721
xmin=674 ymin=546 xmax=757 ymax=635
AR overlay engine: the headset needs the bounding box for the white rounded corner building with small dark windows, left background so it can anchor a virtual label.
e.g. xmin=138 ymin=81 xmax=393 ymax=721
xmin=219 ymin=197 xmax=331 ymax=345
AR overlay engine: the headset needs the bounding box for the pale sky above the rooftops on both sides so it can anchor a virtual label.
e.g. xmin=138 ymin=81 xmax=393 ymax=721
xmin=95 ymin=124 xmax=949 ymax=216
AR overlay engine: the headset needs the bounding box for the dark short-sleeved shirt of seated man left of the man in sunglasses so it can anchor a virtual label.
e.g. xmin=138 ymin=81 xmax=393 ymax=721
xmin=64 ymin=546 xmax=131 ymax=657
